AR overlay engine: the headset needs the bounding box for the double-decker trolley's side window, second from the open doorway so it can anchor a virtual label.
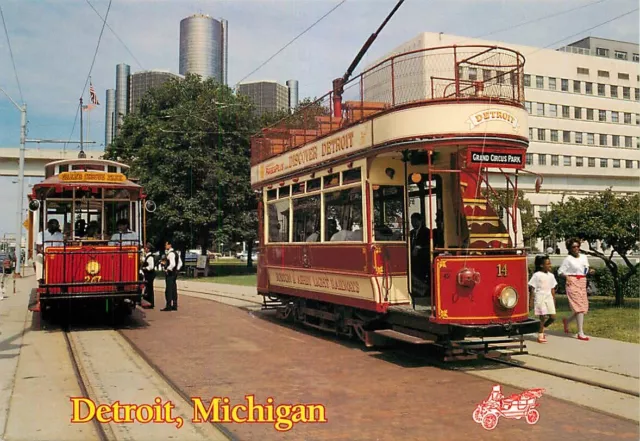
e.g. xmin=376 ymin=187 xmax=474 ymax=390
xmin=324 ymin=187 xmax=363 ymax=242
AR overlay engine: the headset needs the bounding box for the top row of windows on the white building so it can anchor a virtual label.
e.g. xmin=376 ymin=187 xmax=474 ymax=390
xmin=524 ymin=74 xmax=640 ymax=101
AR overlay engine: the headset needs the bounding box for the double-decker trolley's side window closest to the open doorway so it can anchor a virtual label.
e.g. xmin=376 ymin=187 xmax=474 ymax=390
xmin=373 ymin=185 xmax=405 ymax=242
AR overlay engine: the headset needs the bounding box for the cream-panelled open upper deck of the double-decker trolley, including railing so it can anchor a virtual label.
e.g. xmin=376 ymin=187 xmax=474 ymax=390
xmin=251 ymin=45 xmax=529 ymax=188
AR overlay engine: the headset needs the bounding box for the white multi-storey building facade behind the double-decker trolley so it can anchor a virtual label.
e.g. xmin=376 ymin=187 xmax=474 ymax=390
xmin=365 ymin=33 xmax=640 ymax=253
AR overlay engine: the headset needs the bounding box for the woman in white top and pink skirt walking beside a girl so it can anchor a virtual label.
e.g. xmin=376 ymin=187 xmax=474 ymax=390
xmin=558 ymin=239 xmax=593 ymax=341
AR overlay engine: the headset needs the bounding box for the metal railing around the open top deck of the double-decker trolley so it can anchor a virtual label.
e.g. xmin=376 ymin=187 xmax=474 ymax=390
xmin=251 ymin=45 xmax=524 ymax=166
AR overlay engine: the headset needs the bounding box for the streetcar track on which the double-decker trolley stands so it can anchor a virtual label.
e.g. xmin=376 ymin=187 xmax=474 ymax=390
xmin=180 ymin=289 xmax=640 ymax=397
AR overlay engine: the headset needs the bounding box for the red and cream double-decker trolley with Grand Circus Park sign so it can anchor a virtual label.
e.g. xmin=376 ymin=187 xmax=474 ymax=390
xmin=251 ymin=41 xmax=541 ymax=358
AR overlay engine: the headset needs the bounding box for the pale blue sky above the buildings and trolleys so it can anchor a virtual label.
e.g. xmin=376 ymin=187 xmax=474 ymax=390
xmin=0 ymin=0 xmax=638 ymax=234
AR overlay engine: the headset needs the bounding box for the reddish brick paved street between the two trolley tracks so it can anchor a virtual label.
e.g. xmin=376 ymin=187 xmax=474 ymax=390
xmin=124 ymin=296 xmax=638 ymax=441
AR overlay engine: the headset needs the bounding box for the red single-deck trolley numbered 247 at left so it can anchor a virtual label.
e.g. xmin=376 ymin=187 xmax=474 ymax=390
xmin=29 ymin=158 xmax=155 ymax=318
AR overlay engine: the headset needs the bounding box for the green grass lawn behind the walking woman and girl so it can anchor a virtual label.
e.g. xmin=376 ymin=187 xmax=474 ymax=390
xmin=530 ymin=294 xmax=640 ymax=343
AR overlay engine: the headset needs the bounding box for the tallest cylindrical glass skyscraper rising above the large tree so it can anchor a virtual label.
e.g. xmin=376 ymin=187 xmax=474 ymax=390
xmin=179 ymin=14 xmax=228 ymax=84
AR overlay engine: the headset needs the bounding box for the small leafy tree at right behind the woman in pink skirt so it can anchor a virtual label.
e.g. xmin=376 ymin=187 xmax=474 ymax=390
xmin=536 ymin=188 xmax=640 ymax=306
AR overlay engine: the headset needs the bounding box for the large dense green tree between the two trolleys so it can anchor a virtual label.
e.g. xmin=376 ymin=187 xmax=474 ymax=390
xmin=105 ymin=75 xmax=258 ymax=253
